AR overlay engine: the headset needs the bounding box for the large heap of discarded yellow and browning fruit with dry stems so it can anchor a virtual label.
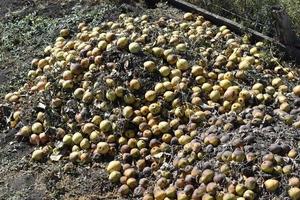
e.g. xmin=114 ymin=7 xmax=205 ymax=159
xmin=5 ymin=10 xmax=300 ymax=200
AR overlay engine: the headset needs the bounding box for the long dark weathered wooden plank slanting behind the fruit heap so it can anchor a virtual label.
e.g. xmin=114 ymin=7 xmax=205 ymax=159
xmin=168 ymin=0 xmax=286 ymax=51
